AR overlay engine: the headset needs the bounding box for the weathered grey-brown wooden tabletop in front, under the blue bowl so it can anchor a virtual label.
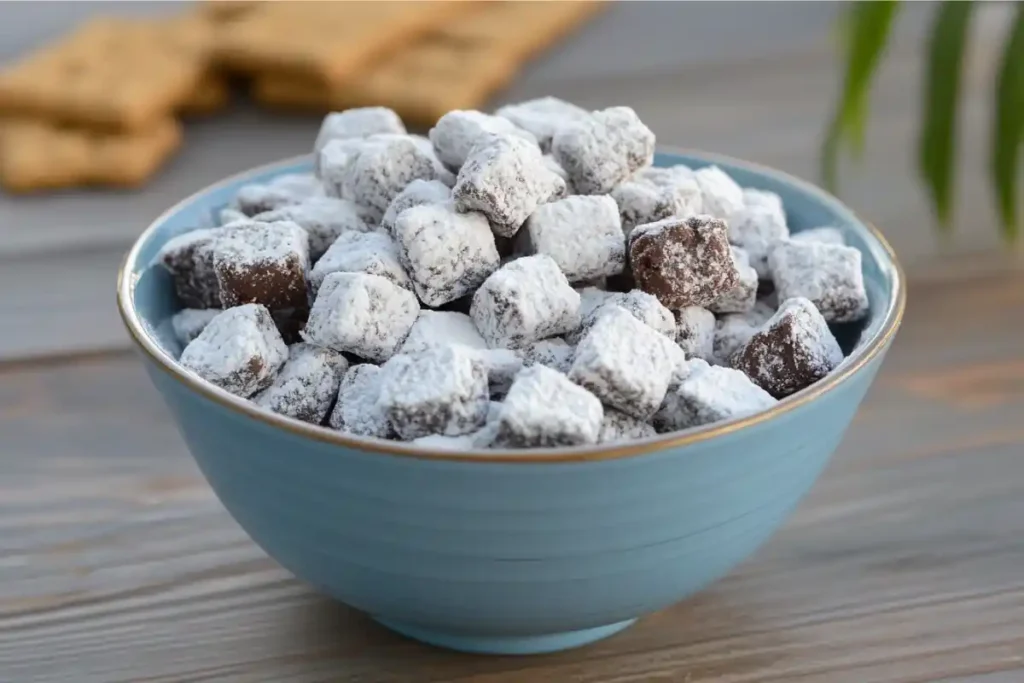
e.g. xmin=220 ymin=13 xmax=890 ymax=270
xmin=0 ymin=276 xmax=1024 ymax=683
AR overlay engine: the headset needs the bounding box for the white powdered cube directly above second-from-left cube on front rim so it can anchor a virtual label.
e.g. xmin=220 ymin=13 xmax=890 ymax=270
xmin=301 ymin=272 xmax=420 ymax=361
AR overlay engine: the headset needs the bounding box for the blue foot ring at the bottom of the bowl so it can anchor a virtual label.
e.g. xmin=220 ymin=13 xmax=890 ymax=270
xmin=375 ymin=618 xmax=636 ymax=654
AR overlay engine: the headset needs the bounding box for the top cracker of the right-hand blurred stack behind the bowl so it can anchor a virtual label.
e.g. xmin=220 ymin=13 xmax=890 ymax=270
xmin=217 ymin=0 xmax=478 ymax=85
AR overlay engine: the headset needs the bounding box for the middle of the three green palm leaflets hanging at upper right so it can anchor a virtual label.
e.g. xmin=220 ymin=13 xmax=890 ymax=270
xmin=918 ymin=0 xmax=974 ymax=229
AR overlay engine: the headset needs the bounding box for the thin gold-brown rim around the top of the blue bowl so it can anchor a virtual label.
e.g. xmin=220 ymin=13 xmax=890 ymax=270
xmin=117 ymin=146 xmax=906 ymax=464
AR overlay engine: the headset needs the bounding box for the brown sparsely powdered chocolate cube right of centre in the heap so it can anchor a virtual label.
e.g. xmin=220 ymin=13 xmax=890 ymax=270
xmin=630 ymin=215 xmax=739 ymax=309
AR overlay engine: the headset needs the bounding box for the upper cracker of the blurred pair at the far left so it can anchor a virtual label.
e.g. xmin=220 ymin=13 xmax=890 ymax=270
xmin=0 ymin=17 xmax=212 ymax=130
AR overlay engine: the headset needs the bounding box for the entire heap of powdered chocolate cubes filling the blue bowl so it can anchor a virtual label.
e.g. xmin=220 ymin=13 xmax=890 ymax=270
xmin=157 ymin=97 xmax=867 ymax=449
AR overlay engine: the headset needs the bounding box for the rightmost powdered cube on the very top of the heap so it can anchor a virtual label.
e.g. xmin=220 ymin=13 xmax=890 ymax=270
xmin=551 ymin=106 xmax=654 ymax=195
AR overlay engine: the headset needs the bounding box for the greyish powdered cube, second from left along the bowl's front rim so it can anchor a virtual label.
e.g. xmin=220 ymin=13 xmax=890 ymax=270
xmin=253 ymin=344 xmax=348 ymax=425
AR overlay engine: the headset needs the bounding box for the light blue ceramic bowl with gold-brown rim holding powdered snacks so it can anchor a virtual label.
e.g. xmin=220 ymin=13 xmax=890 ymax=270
xmin=118 ymin=154 xmax=905 ymax=653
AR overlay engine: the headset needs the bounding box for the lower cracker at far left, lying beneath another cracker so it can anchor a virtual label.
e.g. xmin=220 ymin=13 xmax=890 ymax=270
xmin=0 ymin=119 xmax=181 ymax=193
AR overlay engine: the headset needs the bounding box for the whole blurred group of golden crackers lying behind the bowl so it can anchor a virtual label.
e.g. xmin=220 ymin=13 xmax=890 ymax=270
xmin=0 ymin=0 xmax=602 ymax=193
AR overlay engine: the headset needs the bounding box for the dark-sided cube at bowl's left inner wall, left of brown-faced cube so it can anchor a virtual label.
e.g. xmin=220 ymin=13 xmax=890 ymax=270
xmin=156 ymin=228 xmax=221 ymax=308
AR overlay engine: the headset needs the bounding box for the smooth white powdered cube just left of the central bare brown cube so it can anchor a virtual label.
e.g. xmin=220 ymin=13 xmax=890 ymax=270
xmin=523 ymin=195 xmax=626 ymax=283
